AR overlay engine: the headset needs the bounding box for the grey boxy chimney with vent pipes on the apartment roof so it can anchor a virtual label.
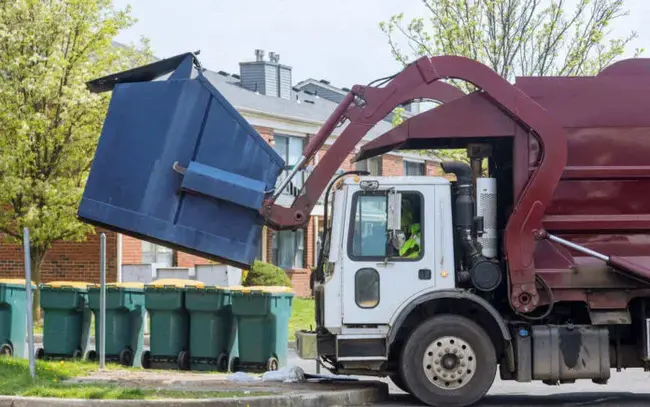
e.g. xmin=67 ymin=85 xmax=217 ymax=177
xmin=239 ymin=49 xmax=292 ymax=99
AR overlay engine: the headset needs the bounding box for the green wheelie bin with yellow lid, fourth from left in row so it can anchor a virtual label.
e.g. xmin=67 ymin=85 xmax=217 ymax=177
xmin=141 ymin=278 xmax=205 ymax=370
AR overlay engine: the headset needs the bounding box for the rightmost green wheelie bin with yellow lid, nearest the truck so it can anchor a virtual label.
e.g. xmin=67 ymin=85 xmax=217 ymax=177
xmin=230 ymin=287 xmax=294 ymax=371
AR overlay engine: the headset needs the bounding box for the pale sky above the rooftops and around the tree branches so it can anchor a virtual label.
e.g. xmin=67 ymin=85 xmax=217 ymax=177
xmin=114 ymin=0 xmax=650 ymax=87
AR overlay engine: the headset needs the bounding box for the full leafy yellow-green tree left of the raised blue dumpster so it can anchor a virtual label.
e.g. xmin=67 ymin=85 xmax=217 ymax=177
xmin=0 ymin=0 xmax=151 ymax=316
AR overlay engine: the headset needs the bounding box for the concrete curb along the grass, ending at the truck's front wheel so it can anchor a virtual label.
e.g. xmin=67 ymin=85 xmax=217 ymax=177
xmin=0 ymin=382 xmax=388 ymax=407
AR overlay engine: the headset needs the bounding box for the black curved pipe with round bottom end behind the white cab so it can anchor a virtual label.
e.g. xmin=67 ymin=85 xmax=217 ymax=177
xmin=441 ymin=162 xmax=502 ymax=291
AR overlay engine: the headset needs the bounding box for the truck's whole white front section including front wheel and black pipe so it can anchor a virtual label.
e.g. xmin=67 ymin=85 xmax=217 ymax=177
xmin=296 ymin=171 xmax=509 ymax=405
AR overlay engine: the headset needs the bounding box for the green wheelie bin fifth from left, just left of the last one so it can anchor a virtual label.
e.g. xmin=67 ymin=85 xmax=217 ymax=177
xmin=185 ymin=286 xmax=236 ymax=371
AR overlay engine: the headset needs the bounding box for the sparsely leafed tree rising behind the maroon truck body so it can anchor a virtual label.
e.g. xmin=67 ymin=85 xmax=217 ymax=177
xmin=380 ymin=0 xmax=643 ymax=163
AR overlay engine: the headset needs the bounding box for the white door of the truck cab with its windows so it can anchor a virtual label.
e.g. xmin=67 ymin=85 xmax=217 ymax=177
xmin=342 ymin=185 xmax=436 ymax=325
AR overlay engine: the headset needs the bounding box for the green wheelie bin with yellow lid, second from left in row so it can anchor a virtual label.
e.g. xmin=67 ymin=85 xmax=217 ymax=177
xmin=36 ymin=281 xmax=92 ymax=359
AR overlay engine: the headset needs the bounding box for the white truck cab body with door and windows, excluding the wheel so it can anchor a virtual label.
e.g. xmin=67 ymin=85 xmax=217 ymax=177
xmin=321 ymin=177 xmax=454 ymax=334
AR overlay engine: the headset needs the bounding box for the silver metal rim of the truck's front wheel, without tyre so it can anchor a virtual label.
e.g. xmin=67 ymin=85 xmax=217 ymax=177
xmin=422 ymin=336 xmax=476 ymax=390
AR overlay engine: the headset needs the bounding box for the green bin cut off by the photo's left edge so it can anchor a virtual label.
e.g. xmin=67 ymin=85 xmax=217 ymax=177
xmin=0 ymin=278 xmax=36 ymax=358
